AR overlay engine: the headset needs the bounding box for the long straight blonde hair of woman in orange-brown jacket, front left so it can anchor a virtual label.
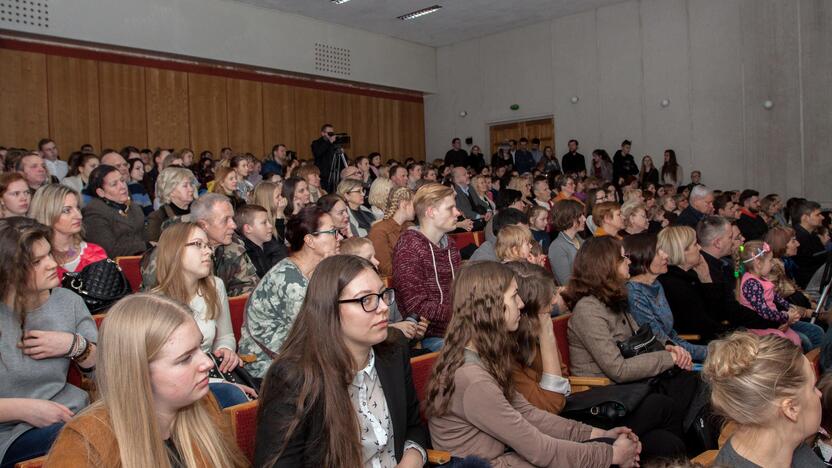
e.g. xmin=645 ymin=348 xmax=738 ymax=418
xmin=89 ymin=293 xmax=248 ymax=468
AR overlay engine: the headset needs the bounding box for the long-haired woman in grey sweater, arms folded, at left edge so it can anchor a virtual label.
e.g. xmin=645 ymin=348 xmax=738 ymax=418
xmin=0 ymin=217 xmax=98 ymax=468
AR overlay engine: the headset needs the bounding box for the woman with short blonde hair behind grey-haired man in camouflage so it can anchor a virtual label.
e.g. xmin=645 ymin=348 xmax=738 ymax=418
xmin=145 ymin=166 xmax=196 ymax=242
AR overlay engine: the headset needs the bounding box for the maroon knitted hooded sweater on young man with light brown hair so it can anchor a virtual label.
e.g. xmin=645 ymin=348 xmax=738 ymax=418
xmin=393 ymin=227 xmax=462 ymax=337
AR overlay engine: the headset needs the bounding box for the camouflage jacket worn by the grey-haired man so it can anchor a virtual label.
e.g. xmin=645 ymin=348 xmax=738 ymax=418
xmin=142 ymin=234 xmax=258 ymax=297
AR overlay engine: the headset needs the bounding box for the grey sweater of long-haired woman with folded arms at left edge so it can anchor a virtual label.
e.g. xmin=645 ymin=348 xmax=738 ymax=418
xmin=0 ymin=288 xmax=98 ymax=460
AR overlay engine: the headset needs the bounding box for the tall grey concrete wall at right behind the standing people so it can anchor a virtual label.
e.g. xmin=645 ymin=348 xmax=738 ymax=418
xmin=425 ymin=0 xmax=832 ymax=204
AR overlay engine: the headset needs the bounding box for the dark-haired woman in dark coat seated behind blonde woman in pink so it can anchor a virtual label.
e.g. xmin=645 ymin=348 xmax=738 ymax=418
xmin=82 ymin=165 xmax=148 ymax=258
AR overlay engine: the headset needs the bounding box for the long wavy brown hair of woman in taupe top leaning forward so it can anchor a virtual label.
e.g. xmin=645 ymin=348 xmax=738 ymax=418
xmin=425 ymin=262 xmax=514 ymax=418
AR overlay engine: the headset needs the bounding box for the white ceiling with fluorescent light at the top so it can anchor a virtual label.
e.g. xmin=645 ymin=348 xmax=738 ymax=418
xmin=231 ymin=0 xmax=623 ymax=47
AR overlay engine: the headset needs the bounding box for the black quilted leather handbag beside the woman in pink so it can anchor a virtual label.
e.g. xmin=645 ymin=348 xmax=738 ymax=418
xmin=61 ymin=258 xmax=132 ymax=314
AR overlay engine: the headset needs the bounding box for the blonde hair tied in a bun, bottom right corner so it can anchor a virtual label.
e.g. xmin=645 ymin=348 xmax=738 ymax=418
xmin=702 ymin=332 xmax=812 ymax=426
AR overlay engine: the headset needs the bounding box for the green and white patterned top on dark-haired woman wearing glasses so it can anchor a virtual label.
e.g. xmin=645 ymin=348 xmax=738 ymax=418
xmin=238 ymin=258 xmax=309 ymax=377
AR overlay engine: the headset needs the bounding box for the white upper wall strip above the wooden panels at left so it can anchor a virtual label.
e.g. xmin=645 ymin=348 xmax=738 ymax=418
xmin=0 ymin=0 xmax=436 ymax=92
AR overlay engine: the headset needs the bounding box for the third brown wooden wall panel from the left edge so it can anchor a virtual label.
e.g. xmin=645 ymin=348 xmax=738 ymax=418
xmin=96 ymin=62 xmax=147 ymax=151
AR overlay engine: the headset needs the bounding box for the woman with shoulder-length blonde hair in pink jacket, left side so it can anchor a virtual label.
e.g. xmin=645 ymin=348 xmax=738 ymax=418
xmin=29 ymin=184 xmax=107 ymax=280
